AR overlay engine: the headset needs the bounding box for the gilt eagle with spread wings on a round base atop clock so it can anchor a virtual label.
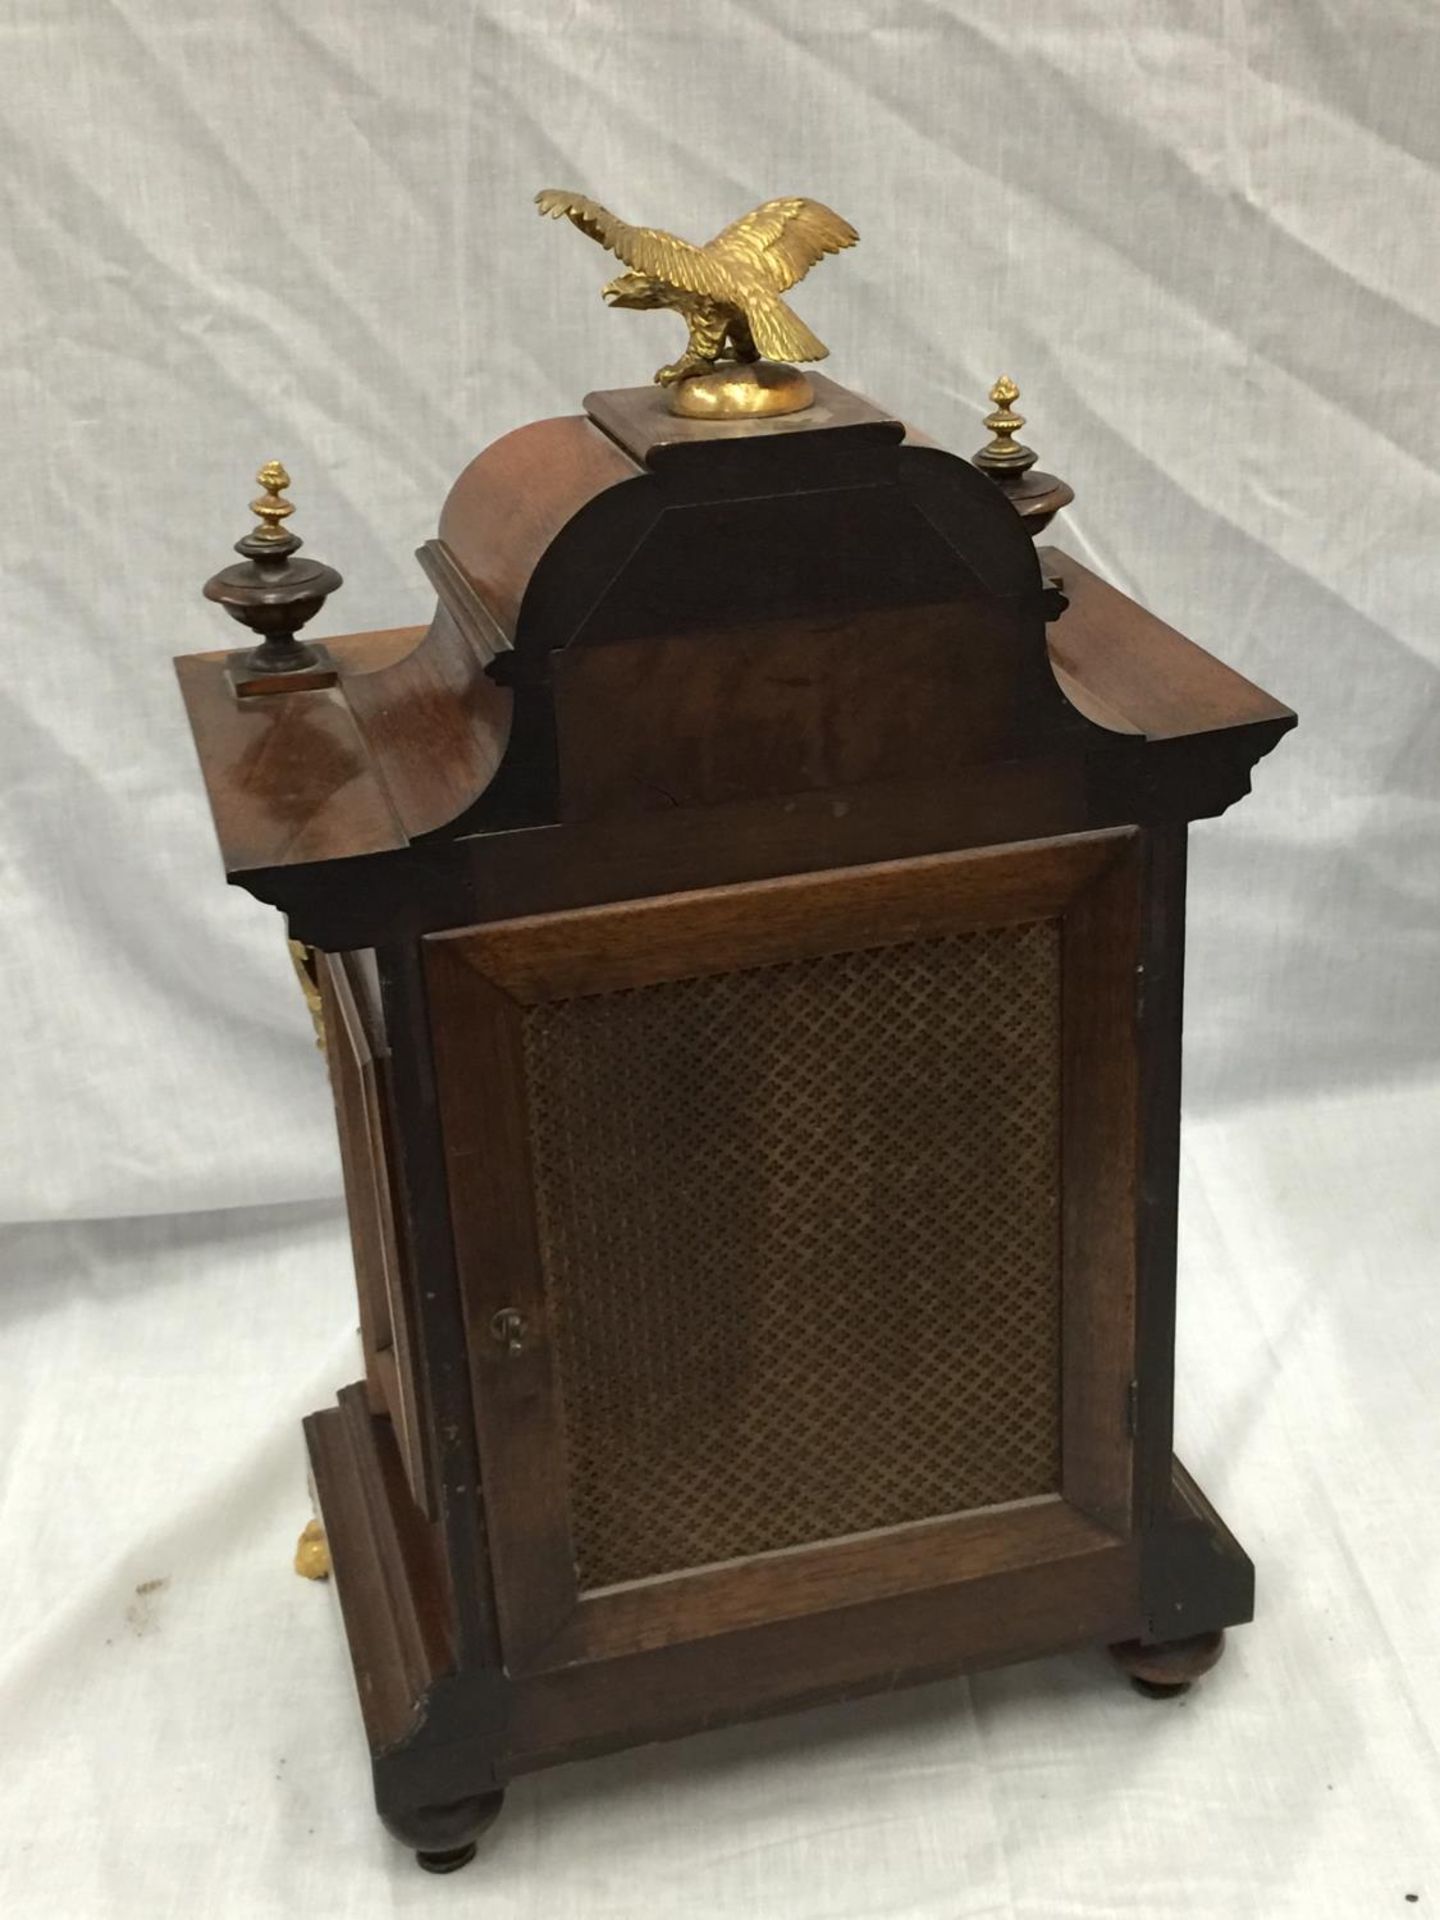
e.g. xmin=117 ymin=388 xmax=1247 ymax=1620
xmin=536 ymin=186 xmax=860 ymax=419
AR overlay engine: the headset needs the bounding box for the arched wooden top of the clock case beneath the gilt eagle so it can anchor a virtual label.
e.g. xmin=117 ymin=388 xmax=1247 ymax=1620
xmin=179 ymin=374 xmax=1294 ymax=943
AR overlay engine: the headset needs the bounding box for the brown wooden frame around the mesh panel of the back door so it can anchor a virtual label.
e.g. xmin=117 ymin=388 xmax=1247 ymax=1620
xmin=422 ymin=828 xmax=1142 ymax=1672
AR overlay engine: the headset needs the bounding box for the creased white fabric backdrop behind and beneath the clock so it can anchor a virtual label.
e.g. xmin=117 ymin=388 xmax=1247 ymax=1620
xmin=0 ymin=0 xmax=1440 ymax=1920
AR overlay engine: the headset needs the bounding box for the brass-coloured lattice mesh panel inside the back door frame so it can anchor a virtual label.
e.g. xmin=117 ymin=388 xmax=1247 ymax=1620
xmin=524 ymin=920 xmax=1060 ymax=1588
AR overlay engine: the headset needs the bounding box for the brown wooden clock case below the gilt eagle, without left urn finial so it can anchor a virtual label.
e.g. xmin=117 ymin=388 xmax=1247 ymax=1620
xmin=179 ymin=198 xmax=1294 ymax=1868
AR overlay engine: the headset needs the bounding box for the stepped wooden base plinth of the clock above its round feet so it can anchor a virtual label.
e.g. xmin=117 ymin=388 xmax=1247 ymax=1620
xmin=305 ymin=1388 xmax=1252 ymax=1781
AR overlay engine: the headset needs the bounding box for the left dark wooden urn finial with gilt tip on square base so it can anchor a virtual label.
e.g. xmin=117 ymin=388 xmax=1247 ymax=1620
xmin=204 ymin=461 xmax=342 ymax=695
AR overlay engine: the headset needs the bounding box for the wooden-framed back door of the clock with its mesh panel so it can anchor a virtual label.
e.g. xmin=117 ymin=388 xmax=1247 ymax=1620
xmin=426 ymin=831 xmax=1139 ymax=1670
